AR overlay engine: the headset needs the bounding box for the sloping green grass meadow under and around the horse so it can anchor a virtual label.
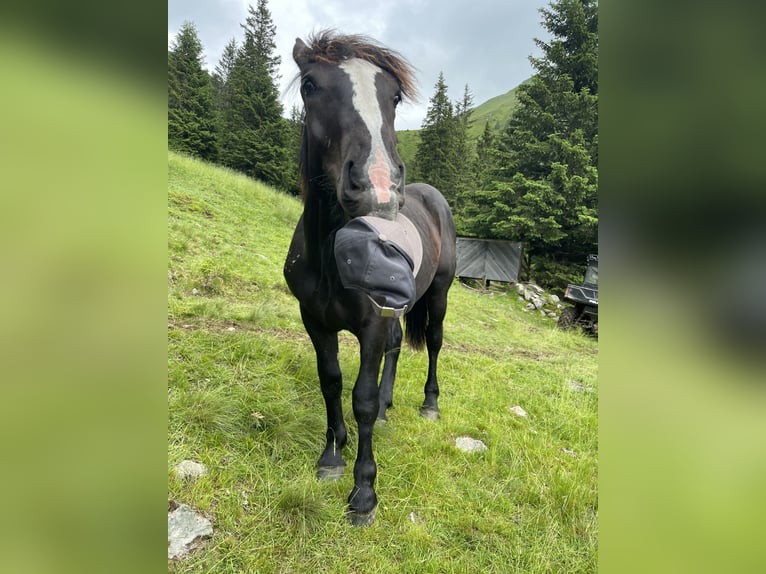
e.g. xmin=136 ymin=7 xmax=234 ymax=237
xmin=168 ymin=153 xmax=598 ymax=573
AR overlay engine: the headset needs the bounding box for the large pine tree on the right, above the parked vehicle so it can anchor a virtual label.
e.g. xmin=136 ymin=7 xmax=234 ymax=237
xmin=488 ymin=0 xmax=598 ymax=285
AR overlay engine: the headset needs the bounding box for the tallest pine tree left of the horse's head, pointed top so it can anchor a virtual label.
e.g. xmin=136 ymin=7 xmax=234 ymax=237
xmin=221 ymin=0 xmax=294 ymax=189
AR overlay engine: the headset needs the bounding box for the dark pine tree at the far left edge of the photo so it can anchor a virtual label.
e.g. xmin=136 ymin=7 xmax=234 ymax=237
xmin=168 ymin=22 xmax=218 ymax=161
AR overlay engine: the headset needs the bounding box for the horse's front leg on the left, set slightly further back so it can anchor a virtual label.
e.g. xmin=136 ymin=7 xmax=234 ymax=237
xmin=303 ymin=314 xmax=347 ymax=479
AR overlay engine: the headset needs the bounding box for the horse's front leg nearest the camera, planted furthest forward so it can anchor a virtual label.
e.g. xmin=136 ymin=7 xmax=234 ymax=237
xmin=348 ymin=324 xmax=390 ymax=526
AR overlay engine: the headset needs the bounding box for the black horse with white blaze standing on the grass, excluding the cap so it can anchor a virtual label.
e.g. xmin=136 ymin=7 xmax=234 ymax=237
xmin=284 ymin=31 xmax=455 ymax=525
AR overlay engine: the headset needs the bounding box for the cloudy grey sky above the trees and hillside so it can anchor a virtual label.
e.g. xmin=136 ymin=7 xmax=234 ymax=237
xmin=168 ymin=0 xmax=550 ymax=130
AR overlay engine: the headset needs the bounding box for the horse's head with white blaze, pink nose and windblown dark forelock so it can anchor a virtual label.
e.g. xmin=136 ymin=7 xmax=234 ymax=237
xmin=293 ymin=31 xmax=414 ymax=220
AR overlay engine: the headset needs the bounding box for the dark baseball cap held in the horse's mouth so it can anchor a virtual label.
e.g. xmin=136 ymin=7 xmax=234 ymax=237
xmin=335 ymin=217 xmax=416 ymax=317
